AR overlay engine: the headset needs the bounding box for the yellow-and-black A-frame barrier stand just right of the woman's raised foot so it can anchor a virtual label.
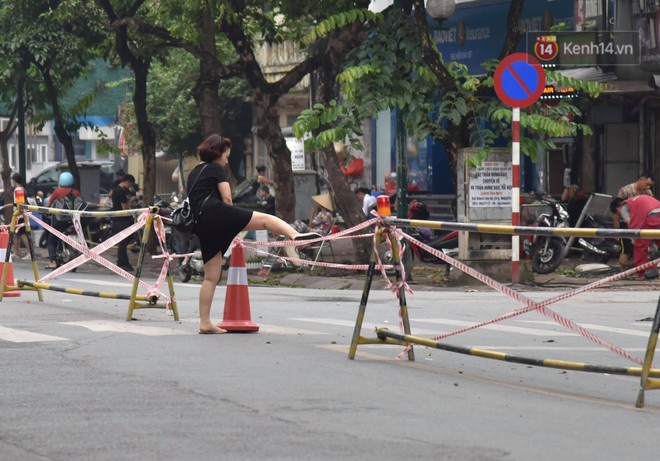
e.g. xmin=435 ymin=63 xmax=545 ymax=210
xmin=348 ymin=226 xmax=415 ymax=361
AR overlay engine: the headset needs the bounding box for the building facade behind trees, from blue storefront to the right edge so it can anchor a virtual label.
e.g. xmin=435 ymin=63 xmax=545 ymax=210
xmin=372 ymin=0 xmax=660 ymax=199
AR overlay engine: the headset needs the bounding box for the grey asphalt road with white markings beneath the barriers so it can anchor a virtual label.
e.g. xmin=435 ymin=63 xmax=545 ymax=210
xmin=0 ymin=265 xmax=660 ymax=461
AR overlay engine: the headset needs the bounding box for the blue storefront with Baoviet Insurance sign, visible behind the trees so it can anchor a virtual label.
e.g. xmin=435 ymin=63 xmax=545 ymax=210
xmin=372 ymin=0 xmax=575 ymax=194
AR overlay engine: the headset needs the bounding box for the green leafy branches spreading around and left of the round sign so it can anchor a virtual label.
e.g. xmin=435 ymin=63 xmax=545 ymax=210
xmin=294 ymin=3 xmax=602 ymax=174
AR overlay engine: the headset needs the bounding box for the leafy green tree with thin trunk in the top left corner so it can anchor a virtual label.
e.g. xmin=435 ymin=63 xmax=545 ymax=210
xmin=0 ymin=0 xmax=111 ymax=188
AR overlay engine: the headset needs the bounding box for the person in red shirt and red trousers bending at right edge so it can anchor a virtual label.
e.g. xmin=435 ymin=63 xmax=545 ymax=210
xmin=610 ymin=195 xmax=660 ymax=278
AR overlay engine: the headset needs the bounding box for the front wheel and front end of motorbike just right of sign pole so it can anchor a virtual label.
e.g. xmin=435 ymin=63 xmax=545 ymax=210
xmin=523 ymin=197 xmax=568 ymax=274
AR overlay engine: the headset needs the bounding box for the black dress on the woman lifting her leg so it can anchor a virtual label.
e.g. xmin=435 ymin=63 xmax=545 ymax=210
xmin=188 ymin=162 xmax=252 ymax=263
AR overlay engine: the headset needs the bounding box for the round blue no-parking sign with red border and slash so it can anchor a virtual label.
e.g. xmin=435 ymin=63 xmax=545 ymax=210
xmin=494 ymin=53 xmax=545 ymax=108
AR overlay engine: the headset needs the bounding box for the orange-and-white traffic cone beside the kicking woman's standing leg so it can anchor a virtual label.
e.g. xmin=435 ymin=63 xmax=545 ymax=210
xmin=218 ymin=246 xmax=259 ymax=331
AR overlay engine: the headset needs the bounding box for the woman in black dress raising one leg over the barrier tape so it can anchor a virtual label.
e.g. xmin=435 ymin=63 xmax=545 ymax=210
xmin=188 ymin=134 xmax=318 ymax=333
